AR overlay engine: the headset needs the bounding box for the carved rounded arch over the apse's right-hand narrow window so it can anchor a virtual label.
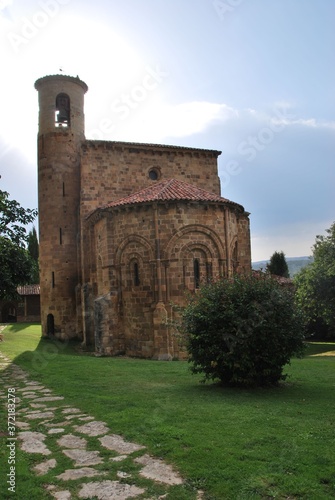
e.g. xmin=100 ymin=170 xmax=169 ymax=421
xmin=163 ymin=224 xmax=226 ymax=260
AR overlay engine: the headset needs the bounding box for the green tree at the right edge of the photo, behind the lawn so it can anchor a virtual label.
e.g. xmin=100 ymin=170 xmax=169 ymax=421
xmin=294 ymin=222 xmax=335 ymax=340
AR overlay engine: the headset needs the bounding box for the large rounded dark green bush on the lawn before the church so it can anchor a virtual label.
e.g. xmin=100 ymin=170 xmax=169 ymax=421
xmin=181 ymin=275 xmax=304 ymax=386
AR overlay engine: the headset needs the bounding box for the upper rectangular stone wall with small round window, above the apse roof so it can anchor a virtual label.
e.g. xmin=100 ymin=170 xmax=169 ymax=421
xmin=81 ymin=141 xmax=220 ymax=217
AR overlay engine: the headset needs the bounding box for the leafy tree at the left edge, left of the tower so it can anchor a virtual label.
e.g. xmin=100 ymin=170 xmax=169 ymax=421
xmin=0 ymin=190 xmax=37 ymax=298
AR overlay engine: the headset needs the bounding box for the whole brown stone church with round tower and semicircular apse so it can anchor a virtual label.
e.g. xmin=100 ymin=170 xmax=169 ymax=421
xmin=35 ymin=75 xmax=251 ymax=360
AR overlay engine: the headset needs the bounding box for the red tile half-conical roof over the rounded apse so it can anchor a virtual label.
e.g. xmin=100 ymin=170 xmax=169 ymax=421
xmin=101 ymin=179 xmax=244 ymax=210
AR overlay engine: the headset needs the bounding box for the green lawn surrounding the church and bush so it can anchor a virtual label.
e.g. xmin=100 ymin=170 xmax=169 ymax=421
xmin=0 ymin=324 xmax=335 ymax=500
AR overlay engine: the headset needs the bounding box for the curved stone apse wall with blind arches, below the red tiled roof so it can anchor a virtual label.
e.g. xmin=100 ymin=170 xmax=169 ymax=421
xmin=85 ymin=202 xmax=250 ymax=359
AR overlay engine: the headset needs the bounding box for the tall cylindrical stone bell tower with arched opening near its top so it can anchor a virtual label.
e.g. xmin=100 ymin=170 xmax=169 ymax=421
xmin=35 ymin=75 xmax=88 ymax=339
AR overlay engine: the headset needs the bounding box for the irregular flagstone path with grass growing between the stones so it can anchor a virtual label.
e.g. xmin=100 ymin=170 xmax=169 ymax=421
xmin=0 ymin=346 xmax=203 ymax=500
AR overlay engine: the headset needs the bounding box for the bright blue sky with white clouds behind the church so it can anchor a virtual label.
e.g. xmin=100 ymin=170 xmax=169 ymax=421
xmin=0 ymin=0 xmax=335 ymax=261
